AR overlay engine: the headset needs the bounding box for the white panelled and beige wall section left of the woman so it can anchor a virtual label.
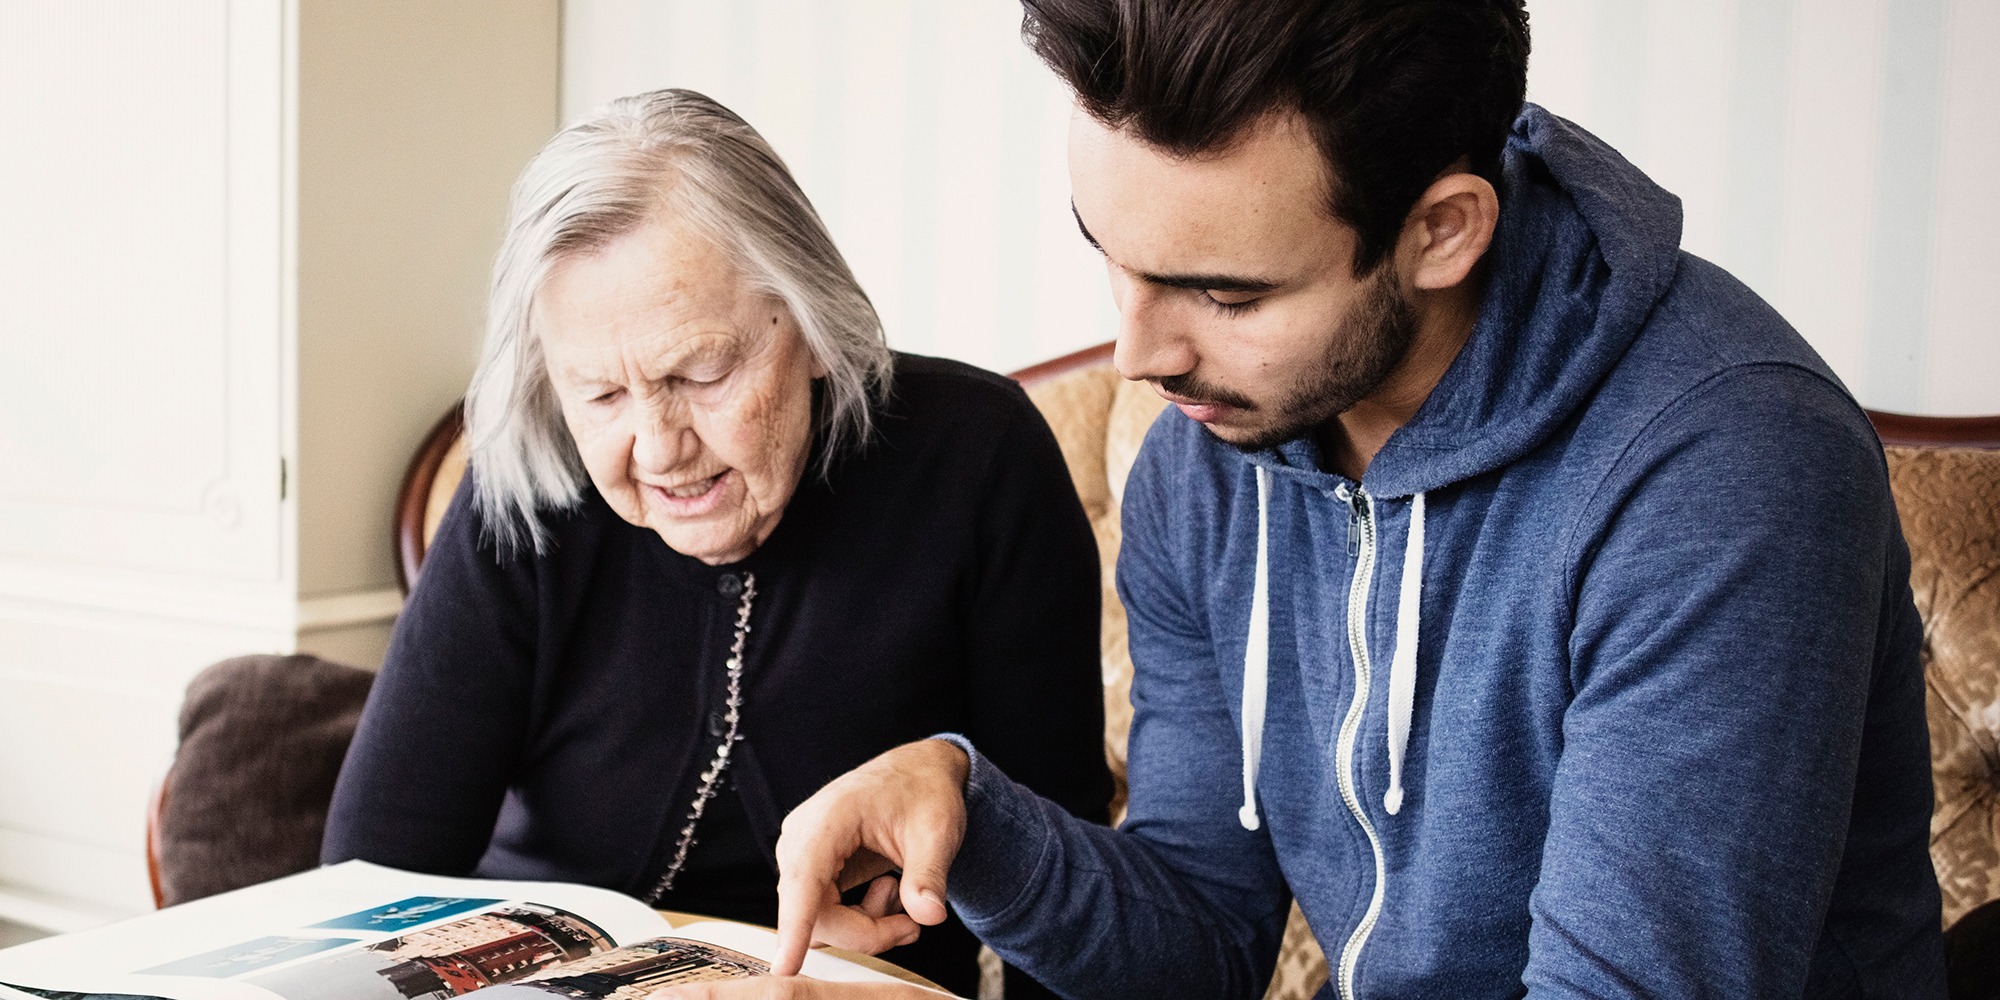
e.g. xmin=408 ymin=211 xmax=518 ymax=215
xmin=0 ymin=0 xmax=558 ymax=930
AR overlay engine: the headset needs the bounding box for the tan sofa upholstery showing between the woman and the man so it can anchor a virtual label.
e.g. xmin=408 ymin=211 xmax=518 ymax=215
xmin=1028 ymin=362 xmax=1326 ymax=1000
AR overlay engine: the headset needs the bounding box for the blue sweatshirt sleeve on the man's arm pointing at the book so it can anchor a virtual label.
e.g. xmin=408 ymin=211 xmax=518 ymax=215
xmin=950 ymin=430 xmax=1290 ymax=998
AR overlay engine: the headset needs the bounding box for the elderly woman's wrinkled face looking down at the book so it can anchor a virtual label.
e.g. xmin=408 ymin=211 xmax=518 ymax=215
xmin=534 ymin=212 xmax=826 ymax=566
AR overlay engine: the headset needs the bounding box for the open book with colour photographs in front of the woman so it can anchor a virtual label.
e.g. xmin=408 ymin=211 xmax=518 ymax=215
xmin=0 ymin=862 xmax=942 ymax=1000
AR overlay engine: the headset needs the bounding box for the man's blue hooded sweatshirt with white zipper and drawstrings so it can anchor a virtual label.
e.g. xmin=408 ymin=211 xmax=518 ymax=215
xmin=950 ymin=106 xmax=1944 ymax=1000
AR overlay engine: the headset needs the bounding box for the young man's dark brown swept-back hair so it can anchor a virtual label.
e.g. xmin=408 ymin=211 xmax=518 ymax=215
xmin=1022 ymin=0 xmax=1528 ymax=274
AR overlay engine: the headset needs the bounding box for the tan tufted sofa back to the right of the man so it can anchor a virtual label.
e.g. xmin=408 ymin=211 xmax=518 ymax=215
xmin=1888 ymin=448 xmax=2000 ymax=926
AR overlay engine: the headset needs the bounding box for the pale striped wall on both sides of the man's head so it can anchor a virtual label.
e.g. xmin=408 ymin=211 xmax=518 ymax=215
xmin=562 ymin=0 xmax=2000 ymax=414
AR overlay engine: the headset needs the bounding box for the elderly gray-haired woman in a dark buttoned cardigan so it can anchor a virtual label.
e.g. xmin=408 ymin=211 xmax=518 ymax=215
xmin=324 ymin=90 xmax=1110 ymax=992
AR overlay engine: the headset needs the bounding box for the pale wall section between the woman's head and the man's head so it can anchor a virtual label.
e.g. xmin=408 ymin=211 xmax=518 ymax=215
xmin=562 ymin=0 xmax=1114 ymax=378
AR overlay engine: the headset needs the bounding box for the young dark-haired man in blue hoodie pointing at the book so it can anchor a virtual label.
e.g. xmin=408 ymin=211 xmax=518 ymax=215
xmin=664 ymin=0 xmax=1944 ymax=998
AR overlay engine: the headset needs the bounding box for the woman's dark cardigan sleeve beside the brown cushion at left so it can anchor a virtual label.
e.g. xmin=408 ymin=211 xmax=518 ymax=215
xmin=320 ymin=474 xmax=536 ymax=876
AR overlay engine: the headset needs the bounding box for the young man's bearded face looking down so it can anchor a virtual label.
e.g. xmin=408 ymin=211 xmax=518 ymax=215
xmin=1070 ymin=114 xmax=1416 ymax=450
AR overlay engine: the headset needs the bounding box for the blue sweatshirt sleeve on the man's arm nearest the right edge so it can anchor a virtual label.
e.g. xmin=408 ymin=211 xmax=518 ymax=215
xmin=1524 ymin=366 xmax=1936 ymax=998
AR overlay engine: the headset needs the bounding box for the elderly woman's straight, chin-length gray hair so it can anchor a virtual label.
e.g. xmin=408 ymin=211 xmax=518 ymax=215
xmin=466 ymin=90 xmax=894 ymax=552
